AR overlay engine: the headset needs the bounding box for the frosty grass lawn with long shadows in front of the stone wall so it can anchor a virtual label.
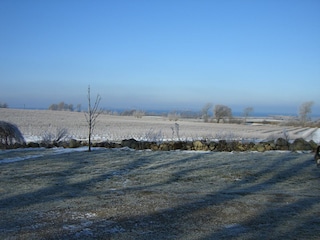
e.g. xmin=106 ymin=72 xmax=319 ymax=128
xmin=0 ymin=149 xmax=320 ymax=240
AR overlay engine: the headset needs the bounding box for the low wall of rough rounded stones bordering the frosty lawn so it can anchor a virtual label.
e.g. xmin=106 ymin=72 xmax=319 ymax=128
xmin=5 ymin=138 xmax=317 ymax=152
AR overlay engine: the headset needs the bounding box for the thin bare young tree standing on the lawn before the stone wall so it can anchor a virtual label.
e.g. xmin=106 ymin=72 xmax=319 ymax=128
xmin=85 ymin=86 xmax=102 ymax=152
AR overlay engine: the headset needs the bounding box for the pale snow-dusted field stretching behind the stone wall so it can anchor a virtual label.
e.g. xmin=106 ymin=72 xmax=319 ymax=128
xmin=0 ymin=109 xmax=320 ymax=143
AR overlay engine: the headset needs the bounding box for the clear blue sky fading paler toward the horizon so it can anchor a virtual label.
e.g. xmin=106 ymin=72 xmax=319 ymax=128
xmin=0 ymin=0 xmax=320 ymax=114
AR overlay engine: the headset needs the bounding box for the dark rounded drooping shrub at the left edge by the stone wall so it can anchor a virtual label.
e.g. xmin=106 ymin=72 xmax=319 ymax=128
xmin=0 ymin=121 xmax=25 ymax=148
